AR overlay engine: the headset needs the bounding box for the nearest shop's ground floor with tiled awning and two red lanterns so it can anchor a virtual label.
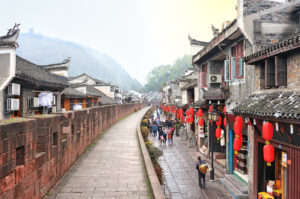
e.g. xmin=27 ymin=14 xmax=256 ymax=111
xmin=233 ymin=92 xmax=300 ymax=199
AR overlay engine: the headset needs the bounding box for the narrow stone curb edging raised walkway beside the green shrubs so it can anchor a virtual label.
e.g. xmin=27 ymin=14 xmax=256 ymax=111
xmin=137 ymin=110 xmax=166 ymax=199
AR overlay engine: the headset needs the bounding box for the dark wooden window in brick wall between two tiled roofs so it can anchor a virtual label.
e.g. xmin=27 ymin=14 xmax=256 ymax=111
xmin=264 ymin=56 xmax=287 ymax=88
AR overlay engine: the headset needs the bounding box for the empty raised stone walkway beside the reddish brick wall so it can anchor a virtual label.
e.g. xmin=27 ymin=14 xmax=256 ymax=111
xmin=45 ymin=108 xmax=150 ymax=199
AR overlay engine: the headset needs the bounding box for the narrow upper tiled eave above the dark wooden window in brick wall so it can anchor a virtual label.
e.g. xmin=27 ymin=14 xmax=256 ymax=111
xmin=244 ymin=35 xmax=300 ymax=62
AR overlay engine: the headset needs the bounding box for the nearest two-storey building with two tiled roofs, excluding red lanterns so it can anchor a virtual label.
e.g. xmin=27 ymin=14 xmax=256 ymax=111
xmin=233 ymin=35 xmax=300 ymax=199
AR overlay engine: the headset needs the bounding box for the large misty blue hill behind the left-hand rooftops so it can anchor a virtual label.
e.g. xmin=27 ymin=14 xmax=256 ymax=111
xmin=17 ymin=31 xmax=142 ymax=90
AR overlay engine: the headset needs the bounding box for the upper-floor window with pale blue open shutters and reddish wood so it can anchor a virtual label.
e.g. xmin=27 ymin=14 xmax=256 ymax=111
xmin=224 ymin=41 xmax=244 ymax=82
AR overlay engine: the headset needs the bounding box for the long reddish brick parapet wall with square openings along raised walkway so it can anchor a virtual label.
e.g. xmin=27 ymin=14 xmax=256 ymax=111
xmin=0 ymin=104 xmax=143 ymax=199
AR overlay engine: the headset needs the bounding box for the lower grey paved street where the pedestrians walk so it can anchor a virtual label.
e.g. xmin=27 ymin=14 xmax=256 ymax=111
xmin=149 ymin=131 xmax=232 ymax=199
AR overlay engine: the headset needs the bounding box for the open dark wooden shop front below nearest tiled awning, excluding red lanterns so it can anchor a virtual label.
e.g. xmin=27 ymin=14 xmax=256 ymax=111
xmin=254 ymin=120 xmax=300 ymax=199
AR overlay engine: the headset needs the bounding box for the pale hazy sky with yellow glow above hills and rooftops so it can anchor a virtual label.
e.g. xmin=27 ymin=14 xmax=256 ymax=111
xmin=0 ymin=0 xmax=236 ymax=83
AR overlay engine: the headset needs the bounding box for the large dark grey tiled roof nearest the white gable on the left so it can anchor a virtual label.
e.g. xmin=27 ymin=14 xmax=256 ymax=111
xmin=16 ymin=56 xmax=68 ymax=88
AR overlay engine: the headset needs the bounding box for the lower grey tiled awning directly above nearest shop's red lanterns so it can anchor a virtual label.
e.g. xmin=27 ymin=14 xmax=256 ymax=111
xmin=232 ymin=92 xmax=300 ymax=119
